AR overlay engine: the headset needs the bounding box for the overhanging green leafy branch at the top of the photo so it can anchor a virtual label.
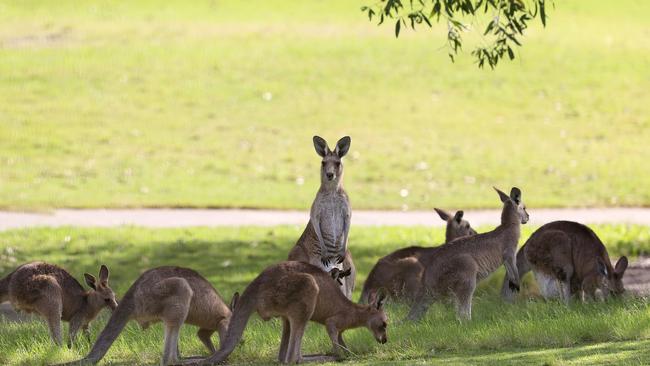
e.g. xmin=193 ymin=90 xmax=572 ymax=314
xmin=361 ymin=0 xmax=552 ymax=68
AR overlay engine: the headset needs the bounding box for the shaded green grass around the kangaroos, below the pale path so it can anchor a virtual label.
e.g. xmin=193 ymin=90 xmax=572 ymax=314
xmin=0 ymin=226 xmax=650 ymax=365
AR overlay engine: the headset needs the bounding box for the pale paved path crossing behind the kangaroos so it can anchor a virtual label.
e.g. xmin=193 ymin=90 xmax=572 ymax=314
xmin=0 ymin=208 xmax=650 ymax=230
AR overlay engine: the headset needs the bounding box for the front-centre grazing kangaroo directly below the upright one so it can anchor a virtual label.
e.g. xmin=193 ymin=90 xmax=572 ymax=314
xmin=191 ymin=261 xmax=387 ymax=364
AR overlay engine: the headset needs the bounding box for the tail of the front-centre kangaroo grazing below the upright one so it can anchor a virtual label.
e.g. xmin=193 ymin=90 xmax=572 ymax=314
xmin=201 ymin=277 xmax=260 ymax=365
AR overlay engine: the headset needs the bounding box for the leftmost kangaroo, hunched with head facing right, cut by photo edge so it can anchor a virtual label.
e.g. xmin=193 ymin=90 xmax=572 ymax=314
xmin=0 ymin=262 xmax=117 ymax=348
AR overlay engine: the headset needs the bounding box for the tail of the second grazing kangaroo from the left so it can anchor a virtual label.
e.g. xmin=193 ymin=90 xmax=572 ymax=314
xmin=82 ymin=286 xmax=135 ymax=364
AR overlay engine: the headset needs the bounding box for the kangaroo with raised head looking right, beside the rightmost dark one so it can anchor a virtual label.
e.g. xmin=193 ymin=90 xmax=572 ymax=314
xmin=408 ymin=187 xmax=528 ymax=320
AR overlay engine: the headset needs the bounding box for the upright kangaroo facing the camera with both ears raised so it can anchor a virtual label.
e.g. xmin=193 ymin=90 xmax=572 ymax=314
xmin=288 ymin=136 xmax=356 ymax=299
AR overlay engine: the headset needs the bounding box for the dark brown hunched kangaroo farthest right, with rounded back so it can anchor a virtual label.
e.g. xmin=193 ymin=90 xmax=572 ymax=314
xmin=502 ymin=221 xmax=628 ymax=304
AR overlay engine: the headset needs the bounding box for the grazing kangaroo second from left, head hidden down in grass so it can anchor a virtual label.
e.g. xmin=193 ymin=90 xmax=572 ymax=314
xmin=59 ymin=266 xmax=234 ymax=365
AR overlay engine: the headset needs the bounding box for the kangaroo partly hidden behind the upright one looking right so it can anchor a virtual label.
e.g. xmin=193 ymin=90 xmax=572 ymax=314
xmin=360 ymin=208 xmax=476 ymax=303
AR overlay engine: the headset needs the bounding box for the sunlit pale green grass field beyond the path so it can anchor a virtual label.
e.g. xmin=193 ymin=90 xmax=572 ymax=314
xmin=0 ymin=0 xmax=650 ymax=209
